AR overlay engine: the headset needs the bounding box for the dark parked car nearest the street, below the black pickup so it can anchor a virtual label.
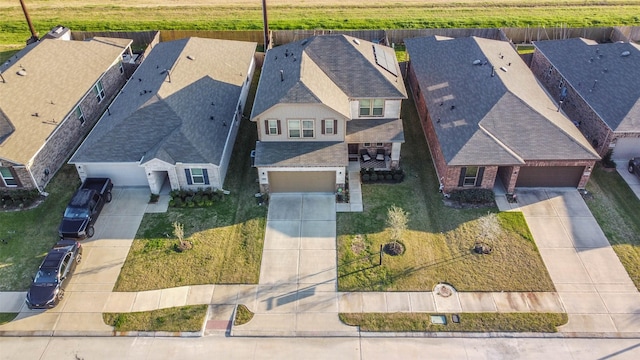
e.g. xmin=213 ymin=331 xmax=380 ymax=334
xmin=25 ymin=239 xmax=82 ymax=309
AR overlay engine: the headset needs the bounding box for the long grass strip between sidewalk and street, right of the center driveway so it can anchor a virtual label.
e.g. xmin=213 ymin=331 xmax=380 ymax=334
xmin=340 ymin=313 xmax=568 ymax=333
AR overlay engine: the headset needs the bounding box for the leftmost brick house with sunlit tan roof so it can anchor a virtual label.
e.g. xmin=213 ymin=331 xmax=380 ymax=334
xmin=0 ymin=33 xmax=132 ymax=192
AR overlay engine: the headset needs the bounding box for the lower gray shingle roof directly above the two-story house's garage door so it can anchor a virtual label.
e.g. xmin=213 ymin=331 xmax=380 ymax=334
xmin=255 ymin=141 xmax=349 ymax=167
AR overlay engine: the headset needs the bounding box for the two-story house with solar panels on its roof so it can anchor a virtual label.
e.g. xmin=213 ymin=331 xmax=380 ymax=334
xmin=251 ymin=35 xmax=407 ymax=192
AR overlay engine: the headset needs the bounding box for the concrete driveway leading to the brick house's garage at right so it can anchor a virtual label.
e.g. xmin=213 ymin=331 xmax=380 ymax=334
xmin=517 ymin=188 xmax=640 ymax=333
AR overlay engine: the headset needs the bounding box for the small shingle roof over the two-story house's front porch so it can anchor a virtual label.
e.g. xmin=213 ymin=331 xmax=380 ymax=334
xmin=345 ymin=119 xmax=404 ymax=143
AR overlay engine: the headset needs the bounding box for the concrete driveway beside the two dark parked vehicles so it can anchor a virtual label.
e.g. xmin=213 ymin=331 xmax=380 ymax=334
xmin=0 ymin=188 xmax=149 ymax=336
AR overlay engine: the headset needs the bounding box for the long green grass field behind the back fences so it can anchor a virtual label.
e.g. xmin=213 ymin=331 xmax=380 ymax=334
xmin=0 ymin=0 xmax=640 ymax=49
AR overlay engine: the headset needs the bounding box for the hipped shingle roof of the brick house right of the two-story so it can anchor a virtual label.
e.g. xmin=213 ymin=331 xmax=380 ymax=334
xmin=405 ymin=36 xmax=599 ymax=166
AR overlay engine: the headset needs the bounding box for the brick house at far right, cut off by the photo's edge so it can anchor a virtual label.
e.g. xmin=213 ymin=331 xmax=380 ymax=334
xmin=531 ymin=38 xmax=640 ymax=160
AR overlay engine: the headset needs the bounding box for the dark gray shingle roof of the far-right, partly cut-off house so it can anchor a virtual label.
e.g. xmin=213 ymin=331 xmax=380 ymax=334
xmin=534 ymin=38 xmax=640 ymax=132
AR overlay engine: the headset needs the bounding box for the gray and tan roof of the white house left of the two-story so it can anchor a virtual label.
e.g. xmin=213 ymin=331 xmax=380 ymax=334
xmin=70 ymin=38 xmax=256 ymax=165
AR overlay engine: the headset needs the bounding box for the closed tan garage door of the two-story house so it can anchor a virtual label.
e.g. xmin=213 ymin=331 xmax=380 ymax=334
xmin=269 ymin=171 xmax=336 ymax=193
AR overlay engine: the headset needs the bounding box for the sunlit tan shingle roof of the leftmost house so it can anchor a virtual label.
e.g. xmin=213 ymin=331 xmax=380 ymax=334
xmin=0 ymin=37 xmax=132 ymax=164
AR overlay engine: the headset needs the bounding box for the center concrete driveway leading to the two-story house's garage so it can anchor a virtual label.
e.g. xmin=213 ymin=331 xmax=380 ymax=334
xmin=234 ymin=193 xmax=356 ymax=336
